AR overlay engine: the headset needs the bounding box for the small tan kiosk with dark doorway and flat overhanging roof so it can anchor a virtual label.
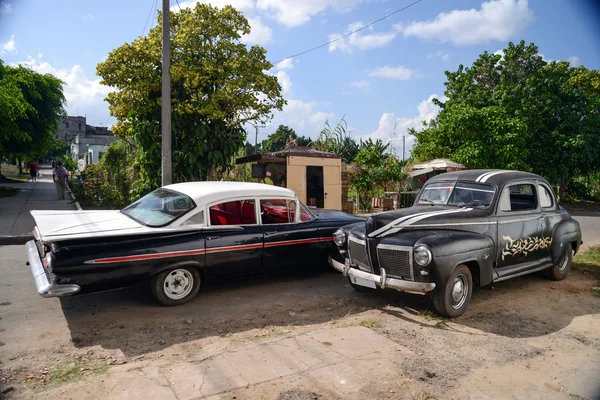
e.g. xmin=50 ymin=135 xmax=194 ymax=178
xmin=236 ymin=146 xmax=348 ymax=210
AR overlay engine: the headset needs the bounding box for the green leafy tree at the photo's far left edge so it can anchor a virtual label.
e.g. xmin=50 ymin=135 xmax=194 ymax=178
xmin=0 ymin=60 xmax=65 ymax=167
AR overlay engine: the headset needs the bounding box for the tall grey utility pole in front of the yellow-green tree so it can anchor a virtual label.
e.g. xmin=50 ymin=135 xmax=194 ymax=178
xmin=161 ymin=0 xmax=173 ymax=186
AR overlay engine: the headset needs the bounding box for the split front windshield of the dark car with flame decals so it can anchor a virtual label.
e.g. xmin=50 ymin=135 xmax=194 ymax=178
xmin=417 ymin=182 xmax=496 ymax=208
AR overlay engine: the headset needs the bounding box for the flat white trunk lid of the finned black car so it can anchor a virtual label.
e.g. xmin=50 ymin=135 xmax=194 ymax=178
xmin=31 ymin=210 xmax=147 ymax=240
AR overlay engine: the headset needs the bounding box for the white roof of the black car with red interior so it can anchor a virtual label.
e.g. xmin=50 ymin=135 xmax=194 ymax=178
xmin=163 ymin=181 xmax=296 ymax=204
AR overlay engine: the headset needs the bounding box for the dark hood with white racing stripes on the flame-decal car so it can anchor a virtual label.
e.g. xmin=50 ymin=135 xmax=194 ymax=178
xmin=366 ymin=206 xmax=488 ymax=237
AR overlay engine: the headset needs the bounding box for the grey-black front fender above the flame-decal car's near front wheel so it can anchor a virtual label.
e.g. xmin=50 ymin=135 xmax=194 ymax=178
xmin=415 ymin=231 xmax=495 ymax=286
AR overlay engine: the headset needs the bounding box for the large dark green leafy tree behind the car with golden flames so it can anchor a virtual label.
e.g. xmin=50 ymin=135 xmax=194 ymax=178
xmin=411 ymin=41 xmax=600 ymax=196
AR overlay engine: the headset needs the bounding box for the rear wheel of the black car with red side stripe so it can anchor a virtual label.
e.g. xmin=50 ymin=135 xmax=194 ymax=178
xmin=152 ymin=267 xmax=202 ymax=306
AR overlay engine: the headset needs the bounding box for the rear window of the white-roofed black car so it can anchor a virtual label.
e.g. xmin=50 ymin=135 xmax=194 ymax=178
xmin=121 ymin=189 xmax=196 ymax=227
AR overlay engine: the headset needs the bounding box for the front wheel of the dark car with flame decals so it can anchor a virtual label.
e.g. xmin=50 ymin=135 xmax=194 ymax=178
xmin=433 ymin=265 xmax=473 ymax=318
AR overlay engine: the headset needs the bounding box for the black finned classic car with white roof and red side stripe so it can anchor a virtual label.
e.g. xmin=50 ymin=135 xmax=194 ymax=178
xmin=26 ymin=182 xmax=364 ymax=306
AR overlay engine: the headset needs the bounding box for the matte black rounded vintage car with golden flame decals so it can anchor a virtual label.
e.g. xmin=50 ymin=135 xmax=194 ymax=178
xmin=329 ymin=170 xmax=582 ymax=317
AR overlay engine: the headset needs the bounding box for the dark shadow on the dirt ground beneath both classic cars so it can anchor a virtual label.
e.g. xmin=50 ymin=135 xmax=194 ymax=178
xmin=61 ymin=271 xmax=600 ymax=356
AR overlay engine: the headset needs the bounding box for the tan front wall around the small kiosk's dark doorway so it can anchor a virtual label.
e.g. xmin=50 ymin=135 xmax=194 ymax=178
xmin=286 ymin=156 xmax=342 ymax=210
